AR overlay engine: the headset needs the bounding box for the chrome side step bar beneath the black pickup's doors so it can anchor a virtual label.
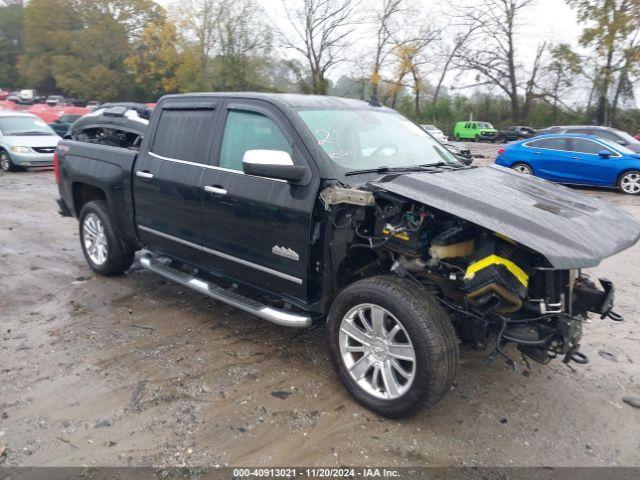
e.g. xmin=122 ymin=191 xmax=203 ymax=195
xmin=140 ymin=255 xmax=311 ymax=328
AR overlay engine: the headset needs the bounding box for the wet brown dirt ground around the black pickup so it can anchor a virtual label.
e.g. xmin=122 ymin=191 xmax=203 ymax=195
xmin=0 ymin=152 xmax=640 ymax=466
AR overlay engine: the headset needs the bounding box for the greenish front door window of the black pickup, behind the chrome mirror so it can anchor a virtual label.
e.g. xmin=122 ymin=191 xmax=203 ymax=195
xmin=220 ymin=110 xmax=293 ymax=171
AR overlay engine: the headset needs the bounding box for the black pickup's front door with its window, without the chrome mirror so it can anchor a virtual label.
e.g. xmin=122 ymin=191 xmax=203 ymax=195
xmin=202 ymin=99 xmax=319 ymax=302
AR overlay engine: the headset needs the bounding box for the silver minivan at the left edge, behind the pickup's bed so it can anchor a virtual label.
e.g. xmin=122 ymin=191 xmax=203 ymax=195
xmin=0 ymin=111 xmax=60 ymax=172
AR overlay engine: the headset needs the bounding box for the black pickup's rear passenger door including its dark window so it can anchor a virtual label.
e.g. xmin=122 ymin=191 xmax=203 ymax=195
xmin=133 ymin=98 xmax=218 ymax=263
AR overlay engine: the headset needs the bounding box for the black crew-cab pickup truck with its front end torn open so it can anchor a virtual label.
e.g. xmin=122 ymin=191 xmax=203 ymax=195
xmin=55 ymin=94 xmax=640 ymax=417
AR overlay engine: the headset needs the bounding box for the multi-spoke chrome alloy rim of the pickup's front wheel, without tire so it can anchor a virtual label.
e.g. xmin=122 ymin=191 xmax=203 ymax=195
xmin=339 ymin=303 xmax=416 ymax=400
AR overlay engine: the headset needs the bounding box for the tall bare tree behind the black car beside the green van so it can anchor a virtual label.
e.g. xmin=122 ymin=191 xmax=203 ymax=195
xmin=459 ymin=0 xmax=535 ymax=122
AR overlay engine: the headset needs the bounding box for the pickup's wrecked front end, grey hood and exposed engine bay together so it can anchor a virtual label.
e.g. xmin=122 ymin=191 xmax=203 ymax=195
xmin=321 ymin=167 xmax=640 ymax=368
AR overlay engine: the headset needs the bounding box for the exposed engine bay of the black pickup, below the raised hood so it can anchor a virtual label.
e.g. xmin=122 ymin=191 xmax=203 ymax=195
xmin=321 ymin=187 xmax=621 ymax=368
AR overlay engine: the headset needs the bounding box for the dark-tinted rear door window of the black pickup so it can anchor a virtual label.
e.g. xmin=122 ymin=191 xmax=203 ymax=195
xmin=150 ymin=109 xmax=215 ymax=164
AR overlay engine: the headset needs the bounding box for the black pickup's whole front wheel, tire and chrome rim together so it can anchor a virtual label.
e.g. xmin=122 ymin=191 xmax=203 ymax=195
xmin=327 ymin=276 xmax=458 ymax=418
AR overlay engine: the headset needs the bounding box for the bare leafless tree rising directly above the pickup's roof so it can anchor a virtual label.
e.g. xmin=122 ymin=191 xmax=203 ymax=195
xmin=282 ymin=0 xmax=357 ymax=95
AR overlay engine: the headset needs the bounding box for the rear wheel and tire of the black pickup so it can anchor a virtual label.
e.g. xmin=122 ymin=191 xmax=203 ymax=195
xmin=80 ymin=200 xmax=135 ymax=277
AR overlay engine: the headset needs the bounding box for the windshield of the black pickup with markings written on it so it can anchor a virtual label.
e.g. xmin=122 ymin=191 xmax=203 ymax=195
xmin=298 ymin=109 xmax=460 ymax=170
